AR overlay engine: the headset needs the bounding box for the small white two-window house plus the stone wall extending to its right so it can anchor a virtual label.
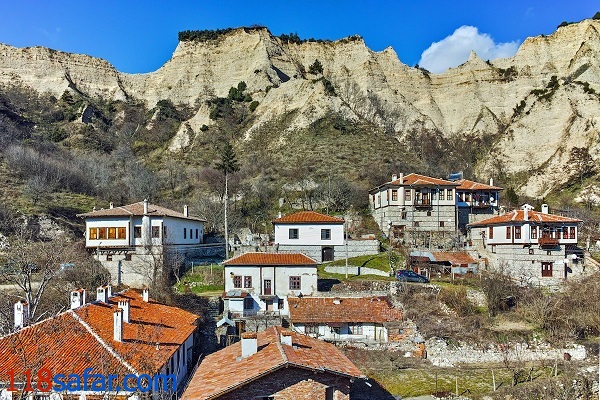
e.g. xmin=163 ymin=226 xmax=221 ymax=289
xmin=273 ymin=211 xmax=379 ymax=263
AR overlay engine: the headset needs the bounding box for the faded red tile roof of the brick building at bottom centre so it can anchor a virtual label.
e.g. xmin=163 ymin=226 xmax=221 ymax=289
xmin=182 ymin=327 xmax=364 ymax=400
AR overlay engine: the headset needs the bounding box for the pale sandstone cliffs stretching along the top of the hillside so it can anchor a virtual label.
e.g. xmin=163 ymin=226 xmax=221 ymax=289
xmin=0 ymin=20 xmax=600 ymax=200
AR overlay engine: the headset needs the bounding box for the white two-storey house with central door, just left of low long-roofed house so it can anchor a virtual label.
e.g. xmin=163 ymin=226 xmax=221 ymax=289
xmin=223 ymin=253 xmax=317 ymax=318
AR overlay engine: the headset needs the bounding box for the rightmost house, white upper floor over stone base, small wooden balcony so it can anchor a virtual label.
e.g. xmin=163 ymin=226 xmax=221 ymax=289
xmin=467 ymin=204 xmax=589 ymax=286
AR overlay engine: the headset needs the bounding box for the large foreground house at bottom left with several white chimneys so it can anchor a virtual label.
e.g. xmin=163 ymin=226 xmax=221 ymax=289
xmin=0 ymin=286 xmax=199 ymax=400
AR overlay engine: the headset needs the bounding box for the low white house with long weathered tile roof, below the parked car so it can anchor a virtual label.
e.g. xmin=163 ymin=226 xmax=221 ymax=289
xmin=288 ymin=297 xmax=402 ymax=343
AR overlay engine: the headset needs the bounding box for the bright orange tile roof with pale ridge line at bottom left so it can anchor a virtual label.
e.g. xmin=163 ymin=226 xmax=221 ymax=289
xmin=0 ymin=289 xmax=199 ymax=381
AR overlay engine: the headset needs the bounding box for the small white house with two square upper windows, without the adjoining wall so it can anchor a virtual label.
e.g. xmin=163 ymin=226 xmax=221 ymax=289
xmin=273 ymin=211 xmax=344 ymax=262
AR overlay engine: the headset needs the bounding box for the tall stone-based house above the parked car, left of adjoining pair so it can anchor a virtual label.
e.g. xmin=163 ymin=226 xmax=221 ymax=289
xmin=369 ymin=174 xmax=460 ymax=246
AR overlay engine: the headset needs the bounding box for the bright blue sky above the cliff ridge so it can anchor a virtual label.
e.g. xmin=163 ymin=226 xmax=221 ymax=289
xmin=0 ymin=0 xmax=600 ymax=73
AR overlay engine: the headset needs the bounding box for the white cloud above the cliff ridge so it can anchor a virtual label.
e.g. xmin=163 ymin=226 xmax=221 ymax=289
xmin=419 ymin=25 xmax=519 ymax=74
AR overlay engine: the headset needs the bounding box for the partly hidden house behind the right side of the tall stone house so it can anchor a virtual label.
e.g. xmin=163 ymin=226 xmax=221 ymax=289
xmin=456 ymin=179 xmax=503 ymax=234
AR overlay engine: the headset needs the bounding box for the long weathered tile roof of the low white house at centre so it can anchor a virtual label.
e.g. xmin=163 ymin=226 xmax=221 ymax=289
xmin=288 ymin=297 xmax=402 ymax=324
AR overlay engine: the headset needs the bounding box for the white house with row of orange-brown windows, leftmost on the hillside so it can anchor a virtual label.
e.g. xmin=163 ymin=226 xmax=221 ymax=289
xmin=78 ymin=200 xmax=205 ymax=286
